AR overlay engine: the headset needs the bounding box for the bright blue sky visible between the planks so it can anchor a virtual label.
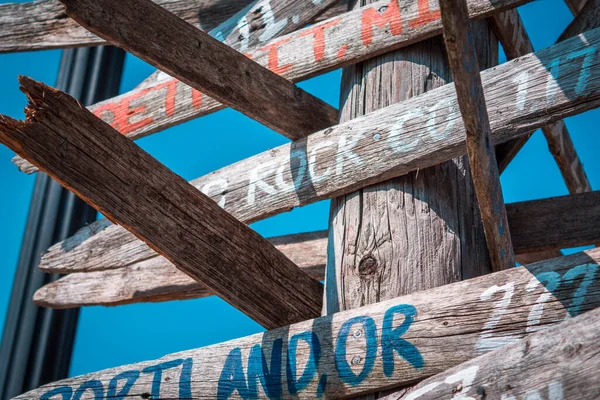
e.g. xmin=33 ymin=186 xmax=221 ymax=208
xmin=0 ymin=0 xmax=600 ymax=375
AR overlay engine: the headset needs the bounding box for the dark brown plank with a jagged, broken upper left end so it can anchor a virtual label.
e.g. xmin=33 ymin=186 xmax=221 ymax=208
xmin=0 ymin=77 xmax=323 ymax=328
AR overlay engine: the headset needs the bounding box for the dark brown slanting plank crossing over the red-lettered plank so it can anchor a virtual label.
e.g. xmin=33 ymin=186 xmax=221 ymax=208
xmin=61 ymin=0 xmax=337 ymax=139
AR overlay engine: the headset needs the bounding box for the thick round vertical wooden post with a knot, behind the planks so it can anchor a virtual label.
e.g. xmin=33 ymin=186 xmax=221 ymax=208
xmin=324 ymin=0 xmax=498 ymax=322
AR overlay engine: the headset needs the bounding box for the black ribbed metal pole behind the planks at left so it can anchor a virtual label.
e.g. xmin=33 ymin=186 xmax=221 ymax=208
xmin=0 ymin=46 xmax=125 ymax=399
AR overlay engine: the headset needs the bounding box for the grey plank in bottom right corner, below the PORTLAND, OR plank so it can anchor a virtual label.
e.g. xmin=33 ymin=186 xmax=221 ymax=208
xmin=383 ymin=298 xmax=600 ymax=400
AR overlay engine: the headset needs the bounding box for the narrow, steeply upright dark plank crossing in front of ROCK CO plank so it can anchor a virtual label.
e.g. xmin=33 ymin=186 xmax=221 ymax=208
xmin=440 ymin=0 xmax=515 ymax=271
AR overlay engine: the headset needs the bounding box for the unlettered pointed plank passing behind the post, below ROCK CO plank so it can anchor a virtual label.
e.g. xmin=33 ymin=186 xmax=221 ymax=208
xmin=34 ymin=192 xmax=600 ymax=308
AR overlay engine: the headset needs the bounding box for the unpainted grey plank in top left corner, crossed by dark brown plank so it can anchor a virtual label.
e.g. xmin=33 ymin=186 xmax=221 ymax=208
xmin=0 ymin=0 xmax=251 ymax=53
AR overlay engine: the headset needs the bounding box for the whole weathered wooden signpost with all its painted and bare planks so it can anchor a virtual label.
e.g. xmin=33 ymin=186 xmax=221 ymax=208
xmin=0 ymin=0 xmax=600 ymax=400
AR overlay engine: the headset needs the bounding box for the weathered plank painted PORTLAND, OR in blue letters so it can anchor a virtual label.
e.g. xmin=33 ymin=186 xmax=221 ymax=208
xmin=12 ymin=249 xmax=600 ymax=399
